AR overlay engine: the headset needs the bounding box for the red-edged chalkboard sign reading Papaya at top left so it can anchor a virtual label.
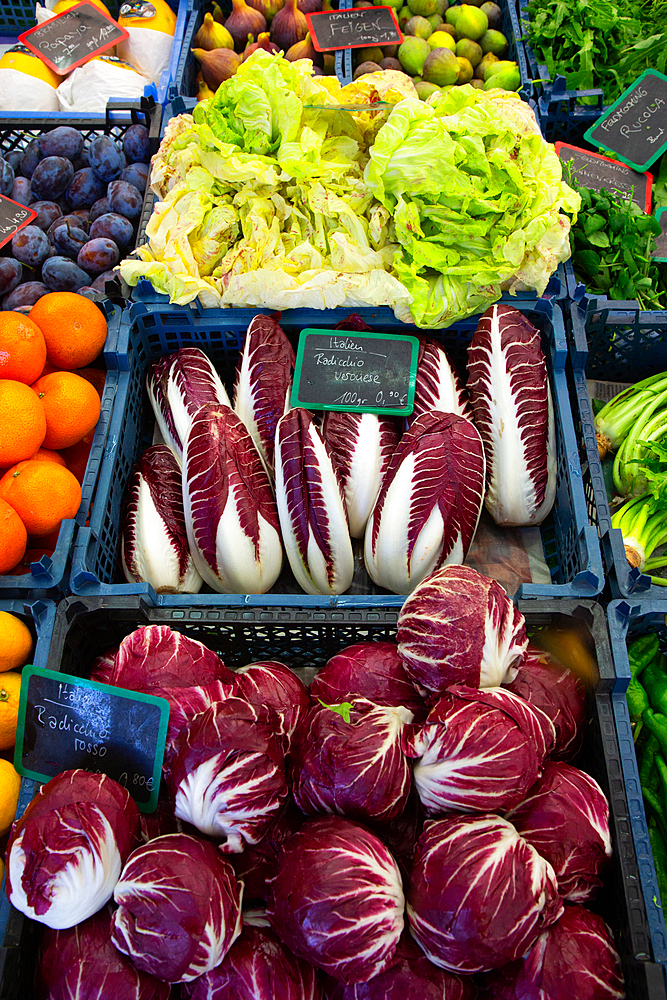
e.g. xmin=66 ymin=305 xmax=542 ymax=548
xmin=19 ymin=2 xmax=129 ymax=76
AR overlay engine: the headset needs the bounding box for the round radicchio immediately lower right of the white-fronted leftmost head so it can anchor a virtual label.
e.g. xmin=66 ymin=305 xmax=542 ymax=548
xmin=111 ymin=833 xmax=243 ymax=983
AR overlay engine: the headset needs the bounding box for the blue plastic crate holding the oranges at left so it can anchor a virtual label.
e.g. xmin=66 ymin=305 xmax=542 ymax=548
xmin=0 ymin=303 xmax=128 ymax=598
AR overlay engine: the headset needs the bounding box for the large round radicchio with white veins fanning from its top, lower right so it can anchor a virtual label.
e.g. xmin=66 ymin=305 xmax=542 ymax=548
xmin=407 ymin=813 xmax=563 ymax=973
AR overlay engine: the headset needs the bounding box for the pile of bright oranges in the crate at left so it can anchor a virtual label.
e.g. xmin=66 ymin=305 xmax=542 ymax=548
xmin=0 ymin=292 xmax=107 ymax=576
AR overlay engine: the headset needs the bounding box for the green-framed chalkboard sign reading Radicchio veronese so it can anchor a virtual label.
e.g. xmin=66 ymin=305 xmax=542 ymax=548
xmin=291 ymin=329 xmax=419 ymax=417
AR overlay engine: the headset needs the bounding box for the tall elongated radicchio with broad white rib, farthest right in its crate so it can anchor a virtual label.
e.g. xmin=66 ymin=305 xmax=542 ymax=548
xmin=468 ymin=305 xmax=557 ymax=526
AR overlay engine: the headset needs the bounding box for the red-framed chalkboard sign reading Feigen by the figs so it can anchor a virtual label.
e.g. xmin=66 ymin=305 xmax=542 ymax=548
xmin=306 ymin=7 xmax=403 ymax=52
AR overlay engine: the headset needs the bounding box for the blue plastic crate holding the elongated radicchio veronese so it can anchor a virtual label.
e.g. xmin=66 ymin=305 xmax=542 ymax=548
xmin=70 ymin=292 xmax=604 ymax=607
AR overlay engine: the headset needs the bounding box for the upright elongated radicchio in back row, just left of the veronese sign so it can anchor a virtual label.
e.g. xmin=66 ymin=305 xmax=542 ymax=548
xmin=234 ymin=314 xmax=295 ymax=472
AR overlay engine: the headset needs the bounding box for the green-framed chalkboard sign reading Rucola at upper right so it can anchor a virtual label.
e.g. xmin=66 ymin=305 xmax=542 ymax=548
xmin=585 ymin=69 xmax=667 ymax=170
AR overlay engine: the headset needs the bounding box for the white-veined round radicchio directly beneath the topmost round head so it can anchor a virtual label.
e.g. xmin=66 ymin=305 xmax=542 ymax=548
xmin=404 ymin=684 xmax=555 ymax=816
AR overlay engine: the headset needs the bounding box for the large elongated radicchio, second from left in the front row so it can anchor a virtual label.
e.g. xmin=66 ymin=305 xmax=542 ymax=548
xmin=183 ymin=406 xmax=283 ymax=594
